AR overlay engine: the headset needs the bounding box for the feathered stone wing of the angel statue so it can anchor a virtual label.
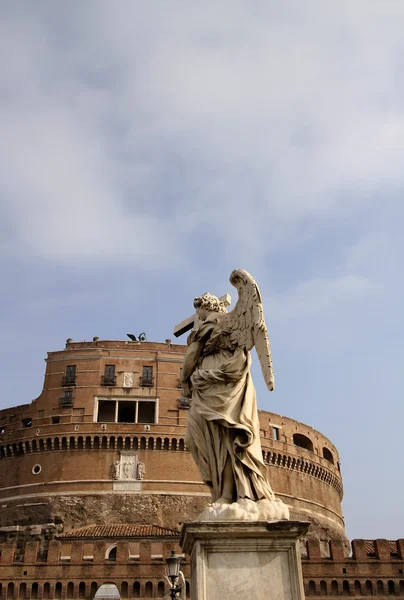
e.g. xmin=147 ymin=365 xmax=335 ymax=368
xmin=223 ymin=269 xmax=275 ymax=392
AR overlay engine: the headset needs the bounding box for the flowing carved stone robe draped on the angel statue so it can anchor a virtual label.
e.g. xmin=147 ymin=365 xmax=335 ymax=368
xmin=185 ymin=313 xmax=274 ymax=502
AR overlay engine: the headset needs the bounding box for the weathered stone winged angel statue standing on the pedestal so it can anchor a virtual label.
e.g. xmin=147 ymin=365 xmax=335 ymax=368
xmin=181 ymin=269 xmax=289 ymax=520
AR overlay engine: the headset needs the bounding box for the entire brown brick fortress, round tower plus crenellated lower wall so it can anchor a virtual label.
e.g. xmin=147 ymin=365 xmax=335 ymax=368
xmin=0 ymin=338 xmax=404 ymax=600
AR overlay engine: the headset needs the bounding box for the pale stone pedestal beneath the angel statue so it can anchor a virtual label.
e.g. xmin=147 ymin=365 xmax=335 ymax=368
xmin=180 ymin=521 xmax=309 ymax=600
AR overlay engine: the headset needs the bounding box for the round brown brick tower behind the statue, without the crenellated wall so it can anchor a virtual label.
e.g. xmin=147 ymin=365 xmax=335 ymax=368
xmin=0 ymin=338 xmax=345 ymax=542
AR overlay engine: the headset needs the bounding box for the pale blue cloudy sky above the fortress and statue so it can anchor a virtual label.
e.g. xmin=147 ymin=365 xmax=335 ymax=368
xmin=0 ymin=0 xmax=404 ymax=539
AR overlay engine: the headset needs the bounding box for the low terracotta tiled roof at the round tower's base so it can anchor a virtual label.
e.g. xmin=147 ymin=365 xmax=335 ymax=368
xmin=56 ymin=523 xmax=180 ymax=539
